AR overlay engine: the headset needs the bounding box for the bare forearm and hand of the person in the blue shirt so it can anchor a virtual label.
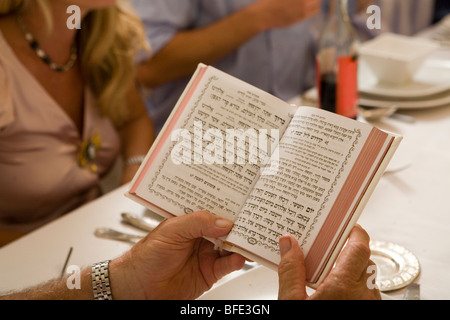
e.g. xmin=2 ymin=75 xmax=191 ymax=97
xmin=138 ymin=0 xmax=321 ymax=88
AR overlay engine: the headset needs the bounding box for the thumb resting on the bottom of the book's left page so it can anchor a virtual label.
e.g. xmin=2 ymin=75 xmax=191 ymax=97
xmin=160 ymin=211 xmax=233 ymax=240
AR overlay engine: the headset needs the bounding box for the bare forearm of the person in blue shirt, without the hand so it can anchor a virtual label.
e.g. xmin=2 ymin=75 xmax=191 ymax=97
xmin=138 ymin=6 xmax=266 ymax=88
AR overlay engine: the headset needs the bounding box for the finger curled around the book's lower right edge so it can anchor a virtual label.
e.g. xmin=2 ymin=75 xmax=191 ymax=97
xmin=336 ymin=225 xmax=370 ymax=281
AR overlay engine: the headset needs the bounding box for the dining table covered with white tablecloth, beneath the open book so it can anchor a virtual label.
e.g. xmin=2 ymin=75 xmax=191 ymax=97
xmin=0 ymin=23 xmax=450 ymax=300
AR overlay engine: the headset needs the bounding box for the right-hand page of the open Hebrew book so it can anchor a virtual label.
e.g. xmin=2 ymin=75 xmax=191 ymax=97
xmin=226 ymin=107 xmax=384 ymax=264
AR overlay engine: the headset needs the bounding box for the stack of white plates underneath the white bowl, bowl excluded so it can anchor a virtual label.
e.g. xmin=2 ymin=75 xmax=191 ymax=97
xmin=358 ymin=58 xmax=450 ymax=109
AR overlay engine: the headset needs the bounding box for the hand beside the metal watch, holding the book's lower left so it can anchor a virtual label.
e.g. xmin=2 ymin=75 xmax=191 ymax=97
xmin=110 ymin=212 xmax=245 ymax=299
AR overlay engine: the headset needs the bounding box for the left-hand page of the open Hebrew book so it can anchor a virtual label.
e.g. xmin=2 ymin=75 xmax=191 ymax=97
xmin=128 ymin=67 xmax=297 ymax=221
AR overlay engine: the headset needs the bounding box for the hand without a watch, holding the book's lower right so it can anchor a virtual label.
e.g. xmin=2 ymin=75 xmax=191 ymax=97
xmin=278 ymin=226 xmax=381 ymax=300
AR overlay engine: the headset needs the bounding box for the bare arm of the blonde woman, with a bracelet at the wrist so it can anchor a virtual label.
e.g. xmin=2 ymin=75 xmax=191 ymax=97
xmin=120 ymin=86 xmax=155 ymax=184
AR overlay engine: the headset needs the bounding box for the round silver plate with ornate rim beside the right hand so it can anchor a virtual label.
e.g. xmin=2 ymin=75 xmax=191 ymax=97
xmin=370 ymin=241 xmax=420 ymax=292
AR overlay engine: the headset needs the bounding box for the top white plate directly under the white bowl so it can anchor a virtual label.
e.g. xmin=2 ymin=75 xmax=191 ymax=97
xmin=358 ymin=59 xmax=450 ymax=100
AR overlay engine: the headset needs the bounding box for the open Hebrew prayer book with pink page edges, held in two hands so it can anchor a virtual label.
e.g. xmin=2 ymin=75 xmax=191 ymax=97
xmin=126 ymin=64 xmax=401 ymax=287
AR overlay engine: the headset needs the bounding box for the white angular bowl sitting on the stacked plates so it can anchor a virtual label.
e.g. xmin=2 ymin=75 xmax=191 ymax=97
xmin=359 ymin=33 xmax=439 ymax=84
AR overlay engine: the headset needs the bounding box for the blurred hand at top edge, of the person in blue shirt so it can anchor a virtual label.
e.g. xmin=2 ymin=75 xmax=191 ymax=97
xmin=254 ymin=0 xmax=322 ymax=29
